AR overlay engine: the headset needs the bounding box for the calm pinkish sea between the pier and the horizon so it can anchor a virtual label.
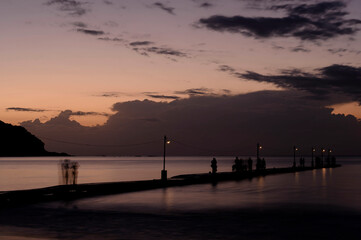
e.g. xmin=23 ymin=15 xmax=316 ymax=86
xmin=0 ymin=157 xmax=304 ymax=191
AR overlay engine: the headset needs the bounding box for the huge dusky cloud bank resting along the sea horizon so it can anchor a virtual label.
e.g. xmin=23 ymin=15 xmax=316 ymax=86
xmin=22 ymin=91 xmax=361 ymax=156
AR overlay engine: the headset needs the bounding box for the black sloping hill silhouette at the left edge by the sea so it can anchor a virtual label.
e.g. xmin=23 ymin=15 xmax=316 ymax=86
xmin=0 ymin=121 xmax=68 ymax=157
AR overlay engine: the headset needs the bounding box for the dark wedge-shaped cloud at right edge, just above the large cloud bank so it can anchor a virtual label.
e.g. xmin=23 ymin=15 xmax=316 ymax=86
xmin=236 ymin=64 xmax=361 ymax=103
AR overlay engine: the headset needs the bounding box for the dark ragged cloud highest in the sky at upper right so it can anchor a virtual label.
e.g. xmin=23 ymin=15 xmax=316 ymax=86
xmin=198 ymin=1 xmax=361 ymax=41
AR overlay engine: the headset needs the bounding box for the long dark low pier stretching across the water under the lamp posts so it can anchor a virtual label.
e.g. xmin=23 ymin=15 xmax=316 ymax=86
xmin=0 ymin=164 xmax=341 ymax=208
